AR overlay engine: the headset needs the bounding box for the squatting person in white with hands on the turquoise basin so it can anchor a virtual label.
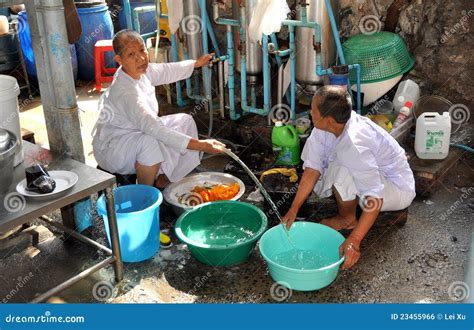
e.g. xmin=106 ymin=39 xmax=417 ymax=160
xmin=283 ymin=86 xmax=415 ymax=269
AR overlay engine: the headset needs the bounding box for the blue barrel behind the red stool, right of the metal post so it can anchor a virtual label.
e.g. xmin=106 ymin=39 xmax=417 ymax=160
xmin=76 ymin=3 xmax=115 ymax=81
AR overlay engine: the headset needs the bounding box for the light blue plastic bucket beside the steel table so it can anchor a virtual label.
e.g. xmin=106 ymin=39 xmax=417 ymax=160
xmin=96 ymin=184 xmax=163 ymax=262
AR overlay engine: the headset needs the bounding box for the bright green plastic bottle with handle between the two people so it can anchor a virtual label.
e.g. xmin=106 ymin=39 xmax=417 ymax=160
xmin=272 ymin=121 xmax=300 ymax=165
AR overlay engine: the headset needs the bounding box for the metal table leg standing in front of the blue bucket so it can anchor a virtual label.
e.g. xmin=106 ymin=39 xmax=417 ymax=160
xmin=105 ymin=186 xmax=123 ymax=282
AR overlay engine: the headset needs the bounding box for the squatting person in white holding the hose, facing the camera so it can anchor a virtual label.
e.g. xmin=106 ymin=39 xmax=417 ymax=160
xmin=92 ymin=30 xmax=224 ymax=188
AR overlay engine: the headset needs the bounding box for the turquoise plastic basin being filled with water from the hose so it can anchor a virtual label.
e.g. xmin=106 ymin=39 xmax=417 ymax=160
xmin=259 ymin=222 xmax=345 ymax=291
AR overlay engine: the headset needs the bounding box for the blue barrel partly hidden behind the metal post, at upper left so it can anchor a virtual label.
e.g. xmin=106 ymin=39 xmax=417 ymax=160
xmin=18 ymin=11 xmax=77 ymax=81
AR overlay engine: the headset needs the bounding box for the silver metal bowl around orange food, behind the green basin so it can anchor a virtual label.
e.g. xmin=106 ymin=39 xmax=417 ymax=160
xmin=163 ymin=172 xmax=245 ymax=215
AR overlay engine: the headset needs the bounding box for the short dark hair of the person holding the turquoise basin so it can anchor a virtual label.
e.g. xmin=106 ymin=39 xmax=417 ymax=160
xmin=313 ymin=85 xmax=352 ymax=124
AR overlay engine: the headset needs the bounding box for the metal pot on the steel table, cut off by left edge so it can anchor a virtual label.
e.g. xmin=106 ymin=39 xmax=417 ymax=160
xmin=0 ymin=128 xmax=19 ymax=193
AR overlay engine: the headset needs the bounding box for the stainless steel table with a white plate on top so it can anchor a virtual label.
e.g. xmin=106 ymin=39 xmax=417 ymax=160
xmin=0 ymin=141 xmax=123 ymax=302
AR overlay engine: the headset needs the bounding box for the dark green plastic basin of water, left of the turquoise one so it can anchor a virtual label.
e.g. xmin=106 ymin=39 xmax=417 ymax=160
xmin=175 ymin=201 xmax=267 ymax=266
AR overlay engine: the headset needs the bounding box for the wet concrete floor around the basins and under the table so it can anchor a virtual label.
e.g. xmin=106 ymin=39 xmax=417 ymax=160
xmin=0 ymin=87 xmax=474 ymax=303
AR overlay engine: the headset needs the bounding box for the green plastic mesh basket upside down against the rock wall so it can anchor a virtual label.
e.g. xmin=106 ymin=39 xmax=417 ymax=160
xmin=343 ymin=31 xmax=415 ymax=83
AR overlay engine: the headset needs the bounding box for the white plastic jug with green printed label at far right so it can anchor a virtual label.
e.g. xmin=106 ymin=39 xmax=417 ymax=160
xmin=415 ymin=112 xmax=451 ymax=159
